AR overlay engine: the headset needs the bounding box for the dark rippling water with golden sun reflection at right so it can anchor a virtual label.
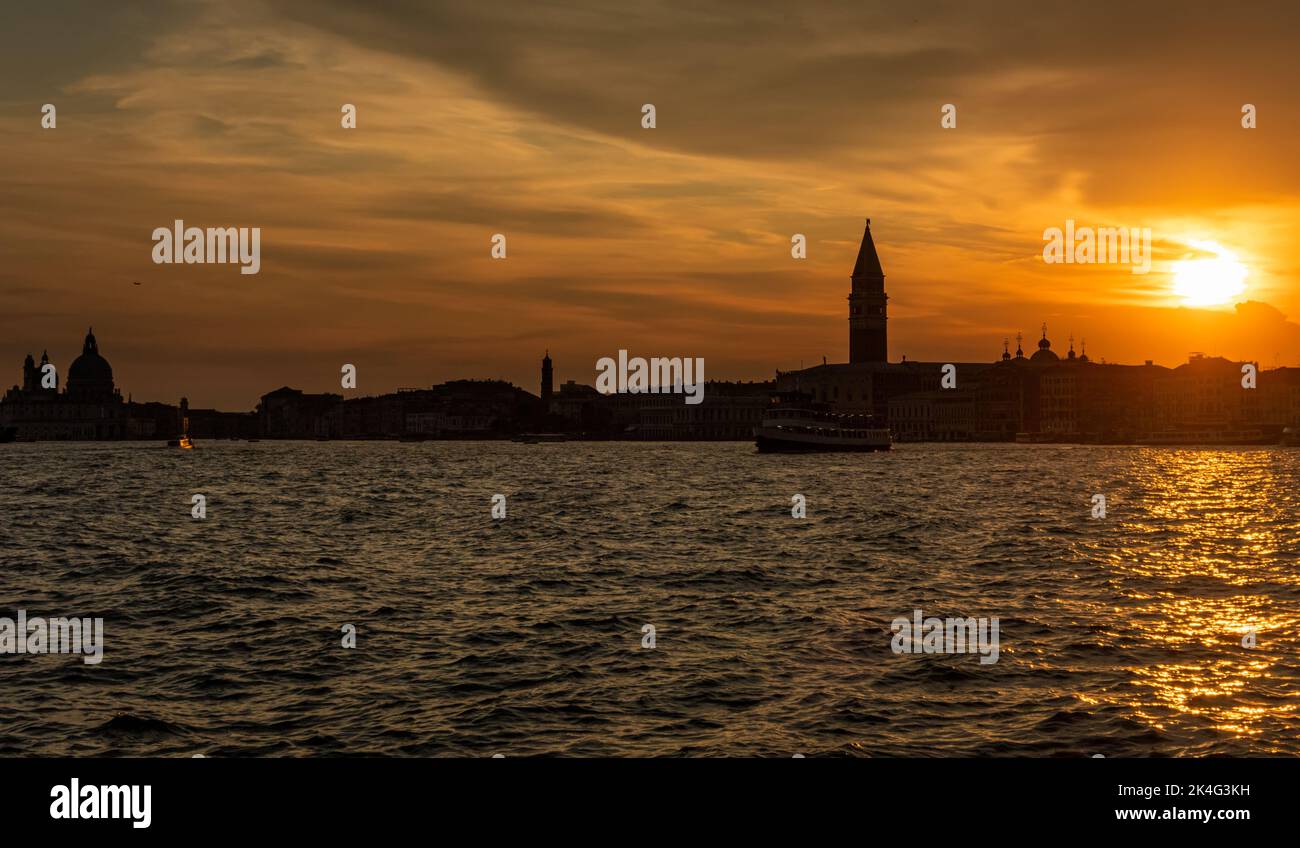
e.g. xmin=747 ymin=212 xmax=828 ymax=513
xmin=0 ymin=442 xmax=1300 ymax=757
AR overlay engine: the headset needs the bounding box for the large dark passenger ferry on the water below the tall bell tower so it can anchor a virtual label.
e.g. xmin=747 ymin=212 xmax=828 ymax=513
xmin=754 ymin=395 xmax=893 ymax=454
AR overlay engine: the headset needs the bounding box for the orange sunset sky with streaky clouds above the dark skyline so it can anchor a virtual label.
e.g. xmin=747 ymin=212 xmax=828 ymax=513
xmin=0 ymin=0 xmax=1300 ymax=410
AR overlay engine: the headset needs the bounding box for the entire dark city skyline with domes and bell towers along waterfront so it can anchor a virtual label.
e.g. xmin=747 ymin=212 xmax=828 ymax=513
xmin=0 ymin=228 xmax=1300 ymax=445
